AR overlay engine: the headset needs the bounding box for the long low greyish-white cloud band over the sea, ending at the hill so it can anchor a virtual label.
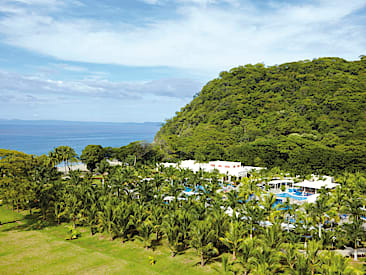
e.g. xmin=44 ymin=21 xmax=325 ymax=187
xmin=0 ymin=71 xmax=202 ymax=102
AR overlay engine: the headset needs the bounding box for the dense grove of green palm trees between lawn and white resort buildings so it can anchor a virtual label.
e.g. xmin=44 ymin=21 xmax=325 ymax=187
xmin=0 ymin=147 xmax=366 ymax=274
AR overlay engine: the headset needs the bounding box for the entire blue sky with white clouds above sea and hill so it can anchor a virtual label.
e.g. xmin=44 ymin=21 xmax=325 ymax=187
xmin=0 ymin=0 xmax=366 ymax=122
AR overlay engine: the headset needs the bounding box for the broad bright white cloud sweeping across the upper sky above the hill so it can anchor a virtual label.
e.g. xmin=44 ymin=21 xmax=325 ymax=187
xmin=0 ymin=0 xmax=366 ymax=72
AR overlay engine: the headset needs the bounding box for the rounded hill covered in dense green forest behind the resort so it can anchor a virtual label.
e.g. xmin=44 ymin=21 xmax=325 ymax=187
xmin=154 ymin=56 xmax=366 ymax=176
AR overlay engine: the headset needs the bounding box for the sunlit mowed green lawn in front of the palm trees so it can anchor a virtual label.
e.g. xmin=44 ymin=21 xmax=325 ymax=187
xmin=0 ymin=206 xmax=219 ymax=275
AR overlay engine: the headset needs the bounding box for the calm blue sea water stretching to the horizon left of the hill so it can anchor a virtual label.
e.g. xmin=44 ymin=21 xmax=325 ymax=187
xmin=0 ymin=120 xmax=161 ymax=155
